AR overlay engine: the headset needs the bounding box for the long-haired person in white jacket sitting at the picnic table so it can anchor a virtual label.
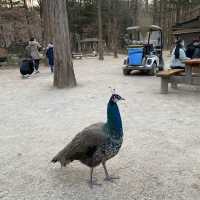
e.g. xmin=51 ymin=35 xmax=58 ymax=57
xmin=170 ymin=39 xmax=190 ymax=69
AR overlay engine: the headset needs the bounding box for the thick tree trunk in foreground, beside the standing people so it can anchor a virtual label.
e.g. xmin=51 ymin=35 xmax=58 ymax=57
xmin=43 ymin=0 xmax=76 ymax=88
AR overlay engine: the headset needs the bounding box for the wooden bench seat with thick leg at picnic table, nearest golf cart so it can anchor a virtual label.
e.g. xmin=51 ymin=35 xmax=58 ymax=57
xmin=156 ymin=69 xmax=184 ymax=94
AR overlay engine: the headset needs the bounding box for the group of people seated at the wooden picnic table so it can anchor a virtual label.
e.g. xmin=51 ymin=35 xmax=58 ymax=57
xmin=171 ymin=37 xmax=200 ymax=69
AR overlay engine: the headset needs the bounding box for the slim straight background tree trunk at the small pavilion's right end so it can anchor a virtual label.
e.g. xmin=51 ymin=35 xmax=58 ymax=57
xmin=97 ymin=0 xmax=104 ymax=60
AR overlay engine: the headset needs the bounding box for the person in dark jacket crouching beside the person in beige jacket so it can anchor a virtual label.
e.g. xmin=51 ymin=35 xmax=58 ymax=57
xmin=20 ymin=59 xmax=34 ymax=78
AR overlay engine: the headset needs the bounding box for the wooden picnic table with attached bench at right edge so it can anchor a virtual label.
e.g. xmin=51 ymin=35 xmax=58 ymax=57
xmin=157 ymin=59 xmax=200 ymax=94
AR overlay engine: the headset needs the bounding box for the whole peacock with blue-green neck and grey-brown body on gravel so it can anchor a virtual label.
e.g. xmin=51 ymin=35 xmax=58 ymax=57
xmin=52 ymin=93 xmax=124 ymax=187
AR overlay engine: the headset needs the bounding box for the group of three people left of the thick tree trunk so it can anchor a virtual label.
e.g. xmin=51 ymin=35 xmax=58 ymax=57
xmin=20 ymin=38 xmax=54 ymax=78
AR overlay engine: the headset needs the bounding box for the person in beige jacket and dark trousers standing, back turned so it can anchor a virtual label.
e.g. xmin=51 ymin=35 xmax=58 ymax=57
xmin=27 ymin=38 xmax=41 ymax=73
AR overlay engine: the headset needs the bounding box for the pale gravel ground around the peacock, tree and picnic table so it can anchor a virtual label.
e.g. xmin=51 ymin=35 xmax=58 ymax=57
xmin=0 ymin=56 xmax=200 ymax=200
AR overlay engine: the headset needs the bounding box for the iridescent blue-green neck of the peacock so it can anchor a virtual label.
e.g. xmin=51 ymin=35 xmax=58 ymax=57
xmin=107 ymin=101 xmax=123 ymax=139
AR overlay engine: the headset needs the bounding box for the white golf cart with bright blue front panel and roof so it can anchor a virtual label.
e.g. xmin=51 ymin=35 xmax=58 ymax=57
xmin=123 ymin=25 xmax=164 ymax=75
